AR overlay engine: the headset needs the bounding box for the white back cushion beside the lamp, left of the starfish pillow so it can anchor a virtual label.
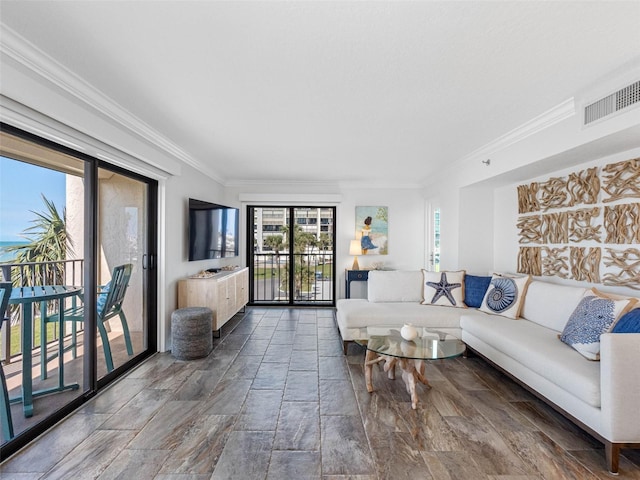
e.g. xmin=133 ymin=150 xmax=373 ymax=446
xmin=367 ymin=270 xmax=422 ymax=304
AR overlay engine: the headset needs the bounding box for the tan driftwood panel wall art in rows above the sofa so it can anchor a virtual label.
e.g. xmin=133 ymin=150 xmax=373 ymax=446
xmin=516 ymin=158 xmax=640 ymax=290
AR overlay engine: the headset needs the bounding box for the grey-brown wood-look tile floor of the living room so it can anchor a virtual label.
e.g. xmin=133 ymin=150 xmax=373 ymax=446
xmin=0 ymin=308 xmax=640 ymax=480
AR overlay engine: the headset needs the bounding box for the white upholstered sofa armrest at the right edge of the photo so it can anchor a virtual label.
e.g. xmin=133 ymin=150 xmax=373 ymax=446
xmin=600 ymin=333 xmax=640 ymax=443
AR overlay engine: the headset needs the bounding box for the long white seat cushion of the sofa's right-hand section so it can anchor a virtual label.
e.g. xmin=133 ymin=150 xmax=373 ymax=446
xmin=460 ymin=316 xmax=600 ymax=407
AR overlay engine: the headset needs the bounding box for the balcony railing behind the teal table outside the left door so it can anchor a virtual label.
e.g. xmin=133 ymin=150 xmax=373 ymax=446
xmin=0 ymin=259 xmax=84 ymax=363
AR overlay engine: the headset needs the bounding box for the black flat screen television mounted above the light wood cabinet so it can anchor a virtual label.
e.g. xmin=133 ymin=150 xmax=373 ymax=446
xmin=189 ymin=198 xmax=240 ymax=261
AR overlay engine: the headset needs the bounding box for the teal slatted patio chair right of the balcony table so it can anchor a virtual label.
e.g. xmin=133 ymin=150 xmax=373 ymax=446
xmin=43 ymin=263 xmax=133 ymax=372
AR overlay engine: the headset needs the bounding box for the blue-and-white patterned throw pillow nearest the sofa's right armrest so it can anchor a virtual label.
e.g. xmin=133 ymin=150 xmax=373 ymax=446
xmin=560 ymin=290 xmax=632 ymax=360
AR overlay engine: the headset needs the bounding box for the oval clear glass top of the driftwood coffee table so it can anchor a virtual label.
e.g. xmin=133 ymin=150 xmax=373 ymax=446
xmin=355 ymin=326 xmax=466 ymax=360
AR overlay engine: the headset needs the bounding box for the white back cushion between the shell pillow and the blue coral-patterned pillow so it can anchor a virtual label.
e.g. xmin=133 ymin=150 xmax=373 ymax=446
xmin=522 ymin=281 xmax=587 ymax=332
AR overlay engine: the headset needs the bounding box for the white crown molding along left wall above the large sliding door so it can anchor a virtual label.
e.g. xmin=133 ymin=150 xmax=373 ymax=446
xmin=0 ymin=22 xmax=224 ymax=184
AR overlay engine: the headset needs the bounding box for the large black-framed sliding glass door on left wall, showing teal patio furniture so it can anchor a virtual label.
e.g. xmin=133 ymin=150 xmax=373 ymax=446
xmin=0 ymin=125 xmax=157 ymax=458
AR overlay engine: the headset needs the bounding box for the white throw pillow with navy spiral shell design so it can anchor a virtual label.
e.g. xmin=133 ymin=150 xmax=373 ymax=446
xmin=480 ymin=273 xmax=531 ymax=318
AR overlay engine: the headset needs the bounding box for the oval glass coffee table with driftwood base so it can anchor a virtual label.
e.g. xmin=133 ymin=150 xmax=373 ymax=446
xmin=355 ymin=325 xmax=466 ymax=410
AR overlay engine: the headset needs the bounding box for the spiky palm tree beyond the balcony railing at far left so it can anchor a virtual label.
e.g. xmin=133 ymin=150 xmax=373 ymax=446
xmin=6 ymin=194 xmax=73 ymax=286
